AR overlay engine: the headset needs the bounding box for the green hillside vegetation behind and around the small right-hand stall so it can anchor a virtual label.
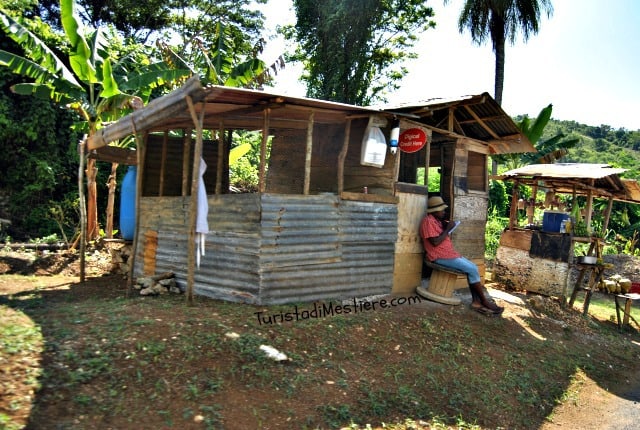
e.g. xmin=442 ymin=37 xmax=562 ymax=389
xmin=485 ymin=109 xmax=640 ymax=261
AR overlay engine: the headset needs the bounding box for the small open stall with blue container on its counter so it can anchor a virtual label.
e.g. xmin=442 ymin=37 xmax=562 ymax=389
xmin=492 ymin=163 xmax=640 ymax=299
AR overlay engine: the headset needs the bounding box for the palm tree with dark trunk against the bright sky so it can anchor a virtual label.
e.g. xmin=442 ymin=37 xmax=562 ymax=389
xmin=444 ymin=0 xmax=553 ymax=104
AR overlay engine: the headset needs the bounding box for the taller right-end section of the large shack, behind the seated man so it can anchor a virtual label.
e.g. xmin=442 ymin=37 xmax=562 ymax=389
xmin=385 ymin=93 xmax=535 ymax=288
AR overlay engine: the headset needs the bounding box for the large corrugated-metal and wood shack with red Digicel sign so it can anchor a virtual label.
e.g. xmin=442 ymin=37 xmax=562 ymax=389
xmin=87 ymin=78 xmax=531 ymax=304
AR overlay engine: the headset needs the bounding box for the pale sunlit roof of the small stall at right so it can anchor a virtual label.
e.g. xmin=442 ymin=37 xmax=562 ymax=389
xmin=498 ymin=163 xmax=640 ymax=203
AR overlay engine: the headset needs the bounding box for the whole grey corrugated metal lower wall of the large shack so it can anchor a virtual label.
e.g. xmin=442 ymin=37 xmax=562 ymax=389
xmin=136 ymin=194 xmax=397 ymax=304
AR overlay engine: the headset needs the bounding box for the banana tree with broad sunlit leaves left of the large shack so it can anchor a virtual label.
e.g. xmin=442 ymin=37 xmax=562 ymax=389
xmin=0 ymin=0 xmax=190 ymax=244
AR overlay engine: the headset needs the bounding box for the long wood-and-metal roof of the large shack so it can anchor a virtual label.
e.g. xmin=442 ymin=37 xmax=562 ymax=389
xmin=88 ymin=76 xmax=535 ymax=153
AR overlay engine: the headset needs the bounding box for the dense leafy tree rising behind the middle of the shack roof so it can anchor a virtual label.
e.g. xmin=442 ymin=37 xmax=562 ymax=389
xmin=285 ymin=0 xmax=435 ymax=105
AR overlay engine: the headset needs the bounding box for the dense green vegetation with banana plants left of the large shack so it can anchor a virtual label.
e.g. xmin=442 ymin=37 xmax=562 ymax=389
xmin=0 ymin=0 xmax=276 ymax=240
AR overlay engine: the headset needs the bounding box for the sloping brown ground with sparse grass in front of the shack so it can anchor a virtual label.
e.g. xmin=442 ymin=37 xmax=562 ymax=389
xmin=0 ymin=278 xmax=640 ymax=430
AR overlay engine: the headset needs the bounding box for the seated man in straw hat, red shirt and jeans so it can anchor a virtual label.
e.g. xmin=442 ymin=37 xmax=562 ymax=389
xmin=420 ymin=196 xmax=504 ymax=315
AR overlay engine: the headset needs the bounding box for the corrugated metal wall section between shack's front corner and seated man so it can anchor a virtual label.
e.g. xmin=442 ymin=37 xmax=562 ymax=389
xmin=260 ymin=195 xmax=397 ymax=303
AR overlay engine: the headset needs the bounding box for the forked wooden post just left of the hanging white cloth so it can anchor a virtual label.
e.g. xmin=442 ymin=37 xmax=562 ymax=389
xmin=186 ymin=97 xmax=206 ymax=305
